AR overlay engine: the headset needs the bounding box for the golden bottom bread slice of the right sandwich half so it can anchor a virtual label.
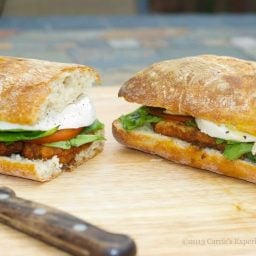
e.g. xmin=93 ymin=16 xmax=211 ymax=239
xmin=112 ymin=120 xmax=256 ymax=183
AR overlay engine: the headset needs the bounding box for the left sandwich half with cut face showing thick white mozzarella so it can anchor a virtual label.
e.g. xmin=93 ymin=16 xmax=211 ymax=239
xmin=0 ymin=57 xmax=104 ymax=181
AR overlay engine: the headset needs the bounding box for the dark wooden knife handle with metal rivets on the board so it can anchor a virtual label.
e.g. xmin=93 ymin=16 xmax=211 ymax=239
xmin=0 ymin=187 xmax=136 ymax=256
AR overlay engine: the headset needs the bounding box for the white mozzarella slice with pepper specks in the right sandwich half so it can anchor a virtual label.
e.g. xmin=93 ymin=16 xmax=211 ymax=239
xmin=195 ymin=118 xmax=256 ymax=142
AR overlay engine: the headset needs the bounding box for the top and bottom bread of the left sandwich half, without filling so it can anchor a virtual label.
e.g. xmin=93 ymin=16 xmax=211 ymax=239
xmin=0 ymin=57 xmax=104 ymax=181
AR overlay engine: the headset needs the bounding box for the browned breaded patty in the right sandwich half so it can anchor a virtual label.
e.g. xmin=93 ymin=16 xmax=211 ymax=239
xmin=153 ymin=120 xmax=224 ymax=151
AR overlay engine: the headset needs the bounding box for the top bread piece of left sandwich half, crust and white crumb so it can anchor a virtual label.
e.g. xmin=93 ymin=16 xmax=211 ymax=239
xmin=0 ymin=56 xmax=99 ymax=125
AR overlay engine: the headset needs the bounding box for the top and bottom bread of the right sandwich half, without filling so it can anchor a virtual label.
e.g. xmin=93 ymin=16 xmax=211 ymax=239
xmin=112 ymin=55 xmax=256 ymax=183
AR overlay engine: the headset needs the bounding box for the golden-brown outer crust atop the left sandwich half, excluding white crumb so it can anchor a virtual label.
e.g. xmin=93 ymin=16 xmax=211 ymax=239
xmin=0 ymin=56 xmax=99 ymax=124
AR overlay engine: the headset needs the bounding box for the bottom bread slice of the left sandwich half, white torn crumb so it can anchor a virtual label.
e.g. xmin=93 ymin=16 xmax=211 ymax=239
xmin=0 ymin=132 xmax=104 ymax=182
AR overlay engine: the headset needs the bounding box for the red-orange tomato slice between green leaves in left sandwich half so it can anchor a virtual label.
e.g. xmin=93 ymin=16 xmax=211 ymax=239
xmin=28 ymin=127 xmax=83 ymax=144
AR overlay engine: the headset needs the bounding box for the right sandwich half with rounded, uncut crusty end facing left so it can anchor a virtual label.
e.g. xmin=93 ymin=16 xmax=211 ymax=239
xmin=112 ymin=55 xmax=256 ymax=183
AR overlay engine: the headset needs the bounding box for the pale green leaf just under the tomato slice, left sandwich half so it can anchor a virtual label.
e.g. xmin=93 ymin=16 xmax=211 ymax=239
xmin=44 ymin=134 xmax=104 ymax=149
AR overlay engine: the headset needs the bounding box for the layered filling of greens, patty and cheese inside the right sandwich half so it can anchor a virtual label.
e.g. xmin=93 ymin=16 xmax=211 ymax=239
xmin=119 ymin=106 xmax=256 ymax=162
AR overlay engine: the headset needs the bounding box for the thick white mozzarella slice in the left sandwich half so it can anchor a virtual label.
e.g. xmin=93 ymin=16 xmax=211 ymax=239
xmin=0 ymin=97 xmax=96 ymax=131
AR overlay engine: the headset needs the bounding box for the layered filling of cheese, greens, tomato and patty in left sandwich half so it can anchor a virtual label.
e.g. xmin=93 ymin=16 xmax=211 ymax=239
xmin=0 ymin=97 xmax=104 ymax=165
